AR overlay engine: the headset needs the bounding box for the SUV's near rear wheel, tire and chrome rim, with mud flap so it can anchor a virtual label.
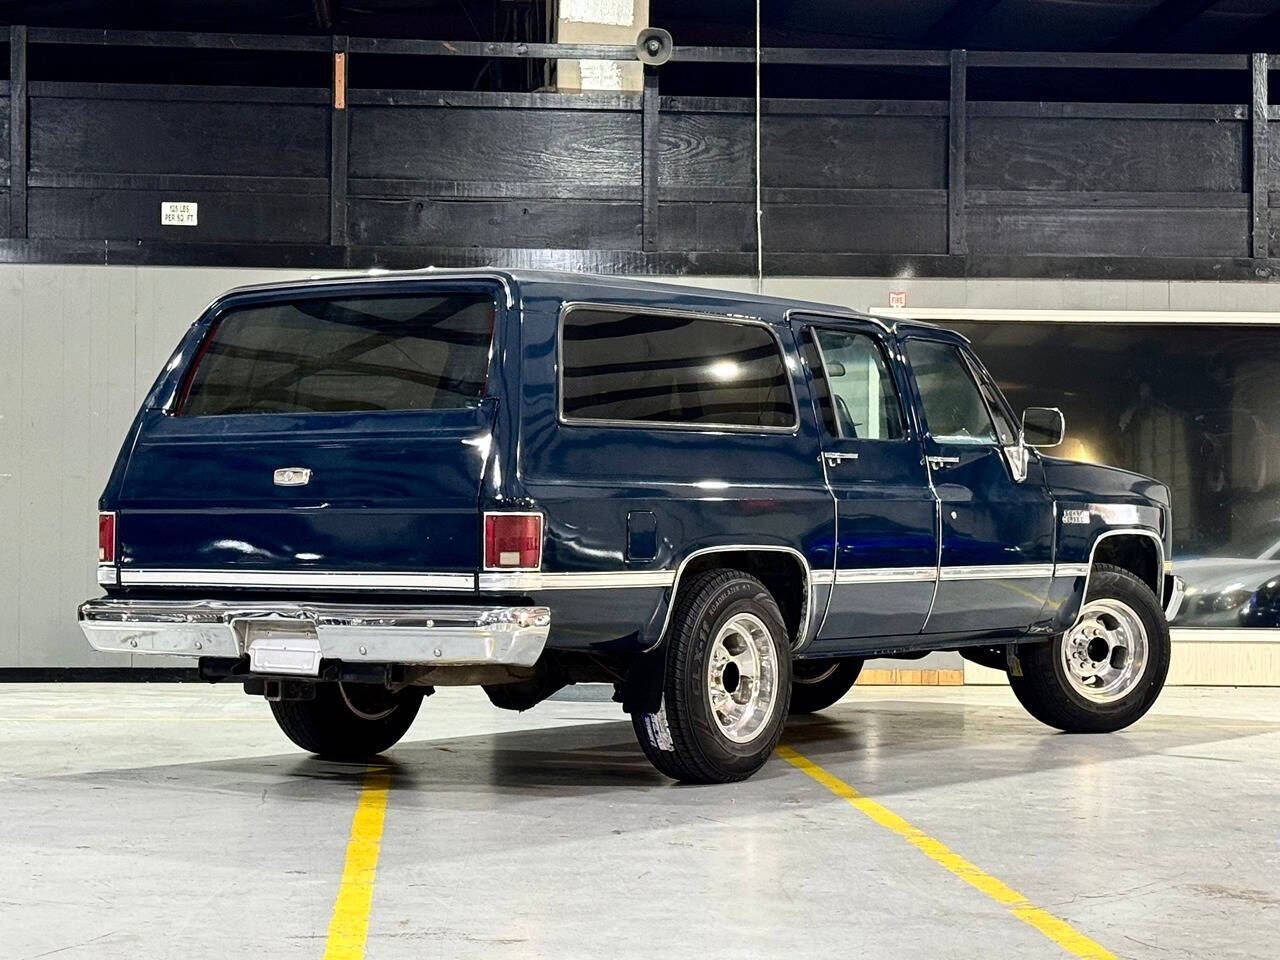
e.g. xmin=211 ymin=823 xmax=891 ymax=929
xmin=631 ymin=570 xmax=791 ymax=783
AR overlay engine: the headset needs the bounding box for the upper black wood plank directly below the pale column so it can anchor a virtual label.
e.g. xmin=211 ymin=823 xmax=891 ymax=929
xmin=348 ymin=106 xmax=641 ymax=187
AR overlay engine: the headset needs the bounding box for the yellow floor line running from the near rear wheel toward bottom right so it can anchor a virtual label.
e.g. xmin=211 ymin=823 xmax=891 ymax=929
xmin=778 ymin=746 xmax=1116 ymax=960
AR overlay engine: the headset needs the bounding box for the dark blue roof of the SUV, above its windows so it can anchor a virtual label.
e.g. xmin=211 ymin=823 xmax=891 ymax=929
xmin=219 ymin=266 xmax=943 ymax=340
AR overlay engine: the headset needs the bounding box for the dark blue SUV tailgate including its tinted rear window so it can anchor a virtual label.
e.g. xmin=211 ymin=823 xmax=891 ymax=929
xmin=116 ymin=281 xmax=497 ymax=590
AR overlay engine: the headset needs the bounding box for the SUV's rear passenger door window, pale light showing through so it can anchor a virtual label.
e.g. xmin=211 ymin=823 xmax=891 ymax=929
xmin=805 ymin=326 xmax=905 ymax=440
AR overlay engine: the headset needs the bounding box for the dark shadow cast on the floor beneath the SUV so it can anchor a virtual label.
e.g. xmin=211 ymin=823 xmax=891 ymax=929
xmin=30 ymin=700 xmax=1280 ymax=806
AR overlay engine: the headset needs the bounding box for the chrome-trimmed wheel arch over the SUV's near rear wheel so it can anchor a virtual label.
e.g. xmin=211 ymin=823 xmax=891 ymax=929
xmin=649 ymin=544 xmax=814 ymax=650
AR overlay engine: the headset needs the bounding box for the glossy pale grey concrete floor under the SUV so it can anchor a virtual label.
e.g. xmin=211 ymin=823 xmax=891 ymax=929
xmin=0 ymin=685 xmax=1280 ymax=960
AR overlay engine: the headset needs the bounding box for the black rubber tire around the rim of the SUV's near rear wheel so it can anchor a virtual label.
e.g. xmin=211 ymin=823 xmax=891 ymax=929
xmin=631 ymin=570 xmax=791 ymax=783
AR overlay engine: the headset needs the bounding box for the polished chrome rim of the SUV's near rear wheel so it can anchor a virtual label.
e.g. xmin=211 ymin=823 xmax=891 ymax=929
xmin=707 ymin=613 xmax=778 ymax=744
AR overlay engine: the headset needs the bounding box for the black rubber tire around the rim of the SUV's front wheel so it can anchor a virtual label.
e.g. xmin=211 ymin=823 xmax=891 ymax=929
xmin=1009 ymin=563 xmax=1169 ymax=733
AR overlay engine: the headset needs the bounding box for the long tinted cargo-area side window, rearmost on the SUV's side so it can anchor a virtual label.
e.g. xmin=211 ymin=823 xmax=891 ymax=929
xmin=561 ymin=307 xmax=795 ymax=428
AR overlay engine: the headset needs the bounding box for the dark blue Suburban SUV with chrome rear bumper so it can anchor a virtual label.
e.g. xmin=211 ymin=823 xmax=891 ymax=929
xmin=79 ymin=269 xmax=1181 ymax=781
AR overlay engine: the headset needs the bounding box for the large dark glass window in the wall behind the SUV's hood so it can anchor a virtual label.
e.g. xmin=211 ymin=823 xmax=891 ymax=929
xmin=946 ymin=321 xmax=1280 ymax=627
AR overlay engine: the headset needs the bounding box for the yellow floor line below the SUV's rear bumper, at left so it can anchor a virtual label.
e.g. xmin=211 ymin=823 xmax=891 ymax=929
xmin=324 ymin=767 xmax=392 ymax=960
